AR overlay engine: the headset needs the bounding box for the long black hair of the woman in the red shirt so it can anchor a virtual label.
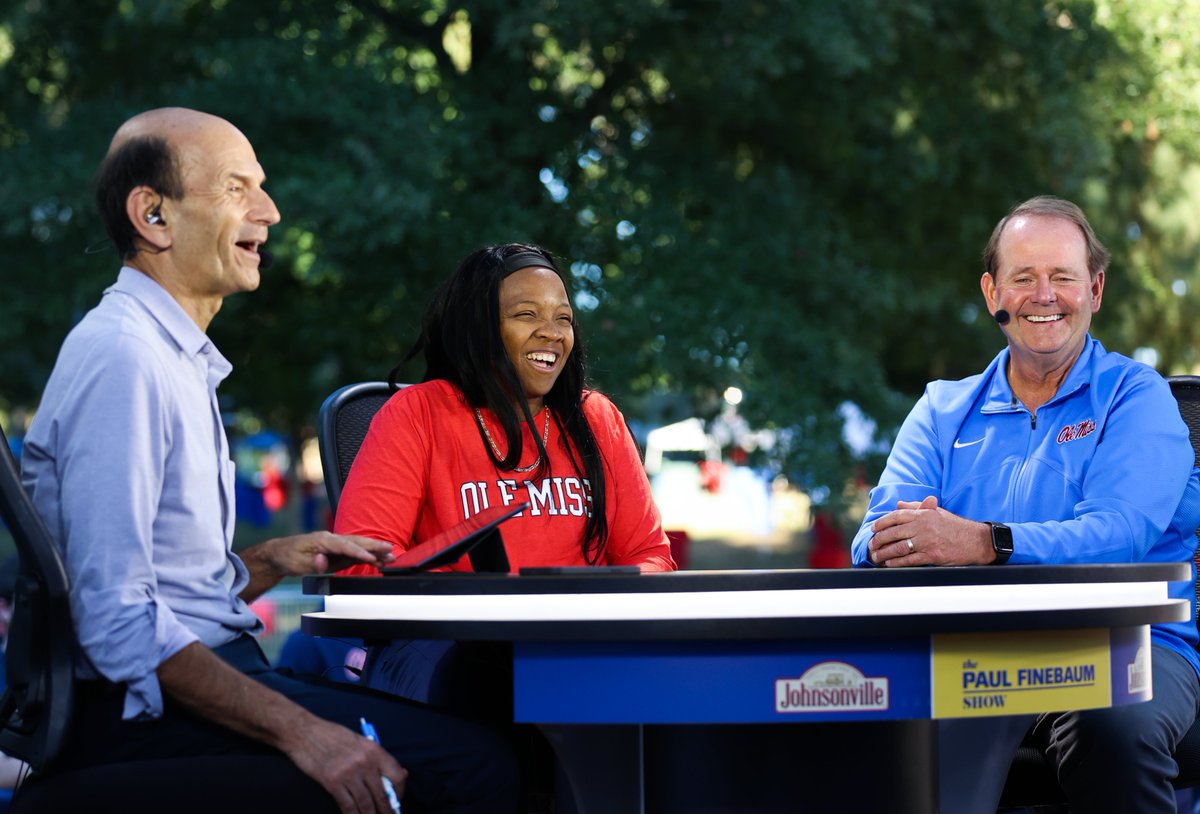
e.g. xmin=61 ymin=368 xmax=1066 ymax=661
xmin=388 ymin=243 xmax=608 ymax=564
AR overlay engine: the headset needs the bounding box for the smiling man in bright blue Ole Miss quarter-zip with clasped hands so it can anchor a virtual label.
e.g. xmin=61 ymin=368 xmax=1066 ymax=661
xmin=852 ymin=197 xmax=1200 ymax=814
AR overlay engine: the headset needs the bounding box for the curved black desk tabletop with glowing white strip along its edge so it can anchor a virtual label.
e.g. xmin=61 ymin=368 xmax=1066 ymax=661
xmin=302 ymin=563 xmax=1192 ymax=641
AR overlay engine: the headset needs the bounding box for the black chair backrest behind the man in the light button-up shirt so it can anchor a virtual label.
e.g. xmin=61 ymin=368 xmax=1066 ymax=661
xmin=0 ymin=431 xmax=76 ymax=771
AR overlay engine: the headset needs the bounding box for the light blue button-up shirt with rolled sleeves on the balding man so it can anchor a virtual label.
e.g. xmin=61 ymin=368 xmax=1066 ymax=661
xmin=22 ymin=267 xmax=262 ymax=718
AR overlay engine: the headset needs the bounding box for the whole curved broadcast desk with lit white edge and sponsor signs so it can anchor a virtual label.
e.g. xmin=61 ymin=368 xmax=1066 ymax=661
xmin=301 ymin=563 xmax=1192 ymax=814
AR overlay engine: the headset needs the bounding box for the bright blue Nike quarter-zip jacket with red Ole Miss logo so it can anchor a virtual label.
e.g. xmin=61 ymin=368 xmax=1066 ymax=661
xmin=851 ymin=336 xmax=1200 ymax=674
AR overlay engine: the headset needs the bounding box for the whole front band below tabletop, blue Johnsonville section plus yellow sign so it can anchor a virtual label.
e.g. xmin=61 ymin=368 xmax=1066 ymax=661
xmin=512 ymin=626 xmax=1150 ymax=724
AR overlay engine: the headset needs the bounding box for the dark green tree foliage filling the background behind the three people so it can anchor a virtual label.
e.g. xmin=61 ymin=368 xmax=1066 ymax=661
xmin=0 ymin=0 xmax=1200 ymax=501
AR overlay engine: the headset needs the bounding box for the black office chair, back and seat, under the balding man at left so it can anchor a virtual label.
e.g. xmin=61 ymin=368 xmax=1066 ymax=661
xmin=0 ymin=431 xmax=337 ymax=814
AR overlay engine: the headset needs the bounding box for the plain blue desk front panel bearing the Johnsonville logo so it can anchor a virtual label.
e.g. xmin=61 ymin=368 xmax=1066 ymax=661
xmin=512 ymin=636 xmax=930 ymax=724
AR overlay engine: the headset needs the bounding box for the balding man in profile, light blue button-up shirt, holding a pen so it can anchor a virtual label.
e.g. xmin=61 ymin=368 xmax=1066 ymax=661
xmin=23 ymin=108 xmax=518 ymax=813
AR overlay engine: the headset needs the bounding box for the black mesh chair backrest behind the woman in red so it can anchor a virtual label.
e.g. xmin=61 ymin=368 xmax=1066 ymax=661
xmin=317 ymin=382 xmax=393 ymax=514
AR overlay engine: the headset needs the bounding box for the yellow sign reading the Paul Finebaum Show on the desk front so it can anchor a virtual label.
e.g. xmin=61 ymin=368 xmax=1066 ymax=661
xmin=932 ymin=628 xmax=1112 ymax=718
